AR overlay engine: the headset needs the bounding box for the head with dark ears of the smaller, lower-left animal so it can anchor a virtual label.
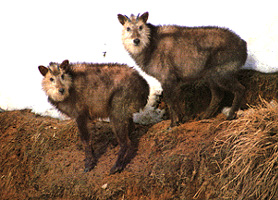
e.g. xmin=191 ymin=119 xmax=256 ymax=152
xmin=39 ymin=60 xmax=72 ymax=101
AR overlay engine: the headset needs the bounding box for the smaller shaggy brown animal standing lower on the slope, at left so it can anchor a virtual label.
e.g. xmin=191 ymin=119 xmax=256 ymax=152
xmin=39 ymin=60 xmax=149 ymax=174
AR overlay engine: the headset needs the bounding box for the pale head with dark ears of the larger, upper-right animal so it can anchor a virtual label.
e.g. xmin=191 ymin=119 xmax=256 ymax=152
xmin=118 ymin=12 xmax=150 ymax=54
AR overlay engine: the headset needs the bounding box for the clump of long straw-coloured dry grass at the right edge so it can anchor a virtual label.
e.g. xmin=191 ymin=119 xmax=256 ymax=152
xmin=215 ymin=100 xmax=278 ymax=200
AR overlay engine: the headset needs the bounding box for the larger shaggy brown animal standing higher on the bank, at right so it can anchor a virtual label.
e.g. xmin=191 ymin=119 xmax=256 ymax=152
xmin=118 ymin=12 xmax=247 ymax=126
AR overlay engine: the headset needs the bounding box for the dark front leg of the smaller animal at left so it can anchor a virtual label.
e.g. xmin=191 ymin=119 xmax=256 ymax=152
xmin=76 ymin=116 xmax=97 ymax=172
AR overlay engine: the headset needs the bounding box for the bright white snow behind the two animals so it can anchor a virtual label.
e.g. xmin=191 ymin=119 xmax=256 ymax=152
xmin=0 ymin=0 xmax=278 ymax=124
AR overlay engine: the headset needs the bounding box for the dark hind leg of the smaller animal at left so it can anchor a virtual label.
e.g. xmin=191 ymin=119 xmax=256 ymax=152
xmin=110 ymin=116 xmax=134 ymax=174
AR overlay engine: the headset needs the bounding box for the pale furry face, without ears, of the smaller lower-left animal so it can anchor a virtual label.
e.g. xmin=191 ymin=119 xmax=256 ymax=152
xmin=42 ymin=65 xmax=72 ymax=101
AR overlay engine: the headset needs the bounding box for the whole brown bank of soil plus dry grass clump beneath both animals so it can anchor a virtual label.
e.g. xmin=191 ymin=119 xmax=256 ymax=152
xmin=0 ymin=70 xmax=278 ymax=200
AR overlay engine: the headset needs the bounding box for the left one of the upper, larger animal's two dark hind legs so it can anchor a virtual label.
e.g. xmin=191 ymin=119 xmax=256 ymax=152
xmin=201 ymin=81 xmax=224 ymax=119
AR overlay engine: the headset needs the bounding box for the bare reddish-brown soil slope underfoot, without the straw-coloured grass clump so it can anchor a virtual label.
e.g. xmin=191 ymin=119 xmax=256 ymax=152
xmin=0 ymin=110 xmax=224 ymax=199
